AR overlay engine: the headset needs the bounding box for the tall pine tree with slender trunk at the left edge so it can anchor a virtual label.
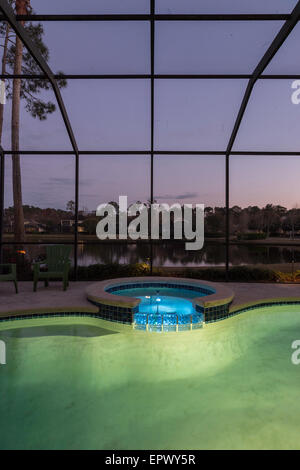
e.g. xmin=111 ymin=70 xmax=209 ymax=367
xmin=0 ymin=0 xmax=67 ymax=243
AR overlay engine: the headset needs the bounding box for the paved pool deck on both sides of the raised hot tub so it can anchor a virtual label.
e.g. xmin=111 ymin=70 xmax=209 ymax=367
xmin=0 ymin=282 xmax=300 ymax=317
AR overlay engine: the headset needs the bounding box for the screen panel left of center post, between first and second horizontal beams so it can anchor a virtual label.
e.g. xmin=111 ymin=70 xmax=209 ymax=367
xmin=37 ymin=21 xmax=150 ymax=75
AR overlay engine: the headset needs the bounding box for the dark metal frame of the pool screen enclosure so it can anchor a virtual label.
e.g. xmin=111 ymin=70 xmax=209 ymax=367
xmin=0 ymin=0 xmax=300 ymax=280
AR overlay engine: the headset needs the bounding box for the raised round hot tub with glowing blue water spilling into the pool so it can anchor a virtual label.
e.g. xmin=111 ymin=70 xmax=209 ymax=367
xmin=87 ymin=277 xmax=233 ymax=332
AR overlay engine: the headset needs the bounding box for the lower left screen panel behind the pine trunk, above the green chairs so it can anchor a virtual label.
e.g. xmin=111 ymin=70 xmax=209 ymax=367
xmin=4 ymin=155 xmax=75 ymax=243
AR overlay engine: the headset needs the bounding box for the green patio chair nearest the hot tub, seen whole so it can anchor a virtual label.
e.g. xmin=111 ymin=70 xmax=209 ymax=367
xmin=33 ymin=245 xmax=72 ymax=292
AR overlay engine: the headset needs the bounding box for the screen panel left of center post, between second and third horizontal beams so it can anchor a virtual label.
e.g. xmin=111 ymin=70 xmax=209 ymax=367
xmin=62 ymin=79 xmax=150 ymax=150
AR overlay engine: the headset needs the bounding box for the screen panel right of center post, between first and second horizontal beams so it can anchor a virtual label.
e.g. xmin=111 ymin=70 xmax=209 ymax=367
xmin=155 ymin=21 xmax=283 ymax=74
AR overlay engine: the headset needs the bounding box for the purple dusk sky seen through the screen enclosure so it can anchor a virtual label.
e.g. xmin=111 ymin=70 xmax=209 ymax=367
xmin=3 ymin=0 xmax=300 ymax=210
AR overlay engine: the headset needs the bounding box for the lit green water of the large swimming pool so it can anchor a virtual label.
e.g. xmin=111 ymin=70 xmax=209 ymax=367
xmin=0 ymin=306 xmax=300 ymax=450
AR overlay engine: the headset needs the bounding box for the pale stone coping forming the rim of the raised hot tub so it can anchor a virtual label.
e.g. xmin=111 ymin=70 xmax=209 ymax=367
xmin=85 ymin=276 xmax=234 ymax=309
